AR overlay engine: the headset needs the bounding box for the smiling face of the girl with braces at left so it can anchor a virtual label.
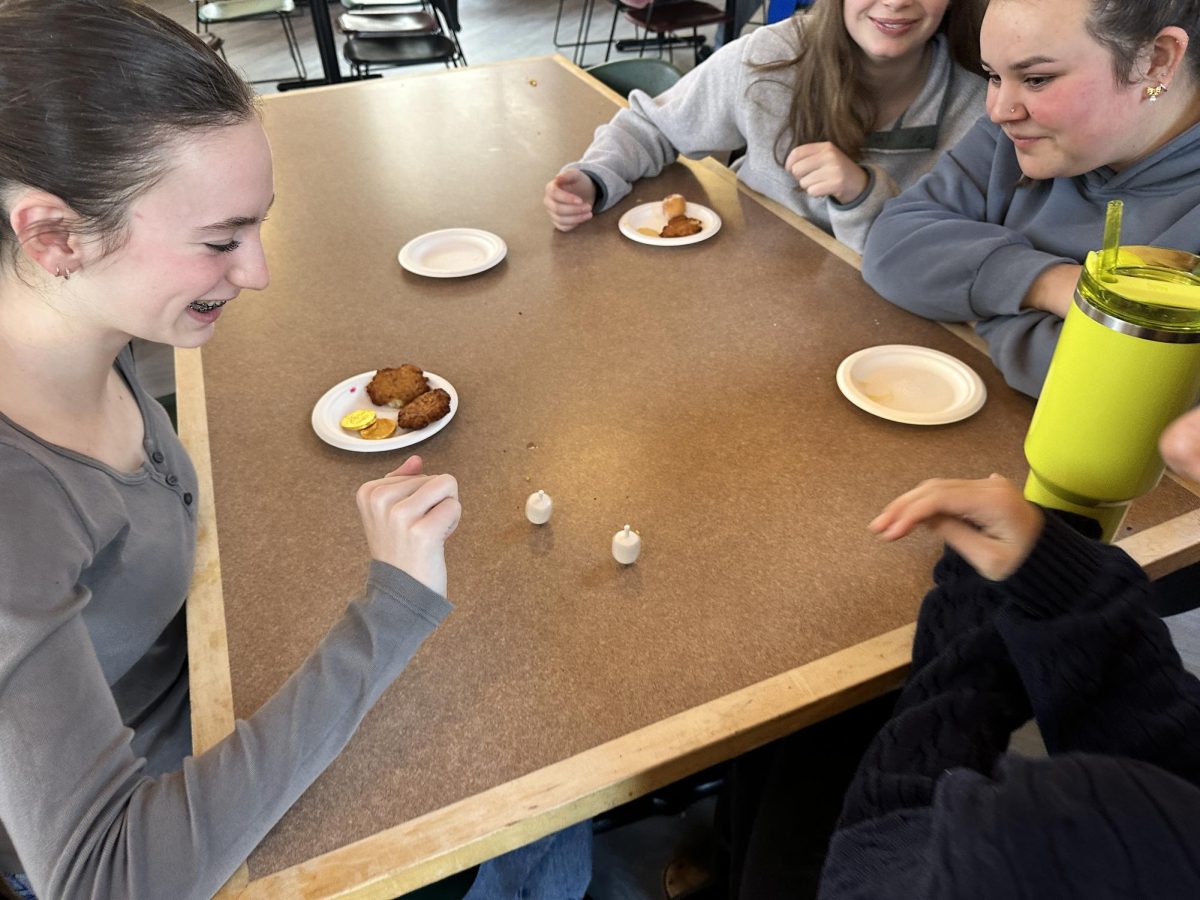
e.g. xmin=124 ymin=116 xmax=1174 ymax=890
xmin=80 ymin=120 xmax=274 ymax=347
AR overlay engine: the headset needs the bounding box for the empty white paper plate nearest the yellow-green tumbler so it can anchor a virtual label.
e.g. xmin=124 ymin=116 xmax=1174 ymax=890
xmin=838 ymin=343 xmax=988 ymax=425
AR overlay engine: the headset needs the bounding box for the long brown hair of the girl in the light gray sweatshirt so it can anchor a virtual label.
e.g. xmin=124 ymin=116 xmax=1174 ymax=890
xmin=751 ymin=0 xmax=983 ymax=164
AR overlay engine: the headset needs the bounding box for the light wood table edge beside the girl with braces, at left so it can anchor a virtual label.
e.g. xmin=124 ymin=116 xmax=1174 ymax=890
xmin=175 ymin=349 xmax=250 ymax=898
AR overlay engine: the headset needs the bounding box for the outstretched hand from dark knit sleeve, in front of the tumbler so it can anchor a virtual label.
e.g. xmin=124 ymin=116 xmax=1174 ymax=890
xmin=868 ymin=475 xmax=1045 ymax=581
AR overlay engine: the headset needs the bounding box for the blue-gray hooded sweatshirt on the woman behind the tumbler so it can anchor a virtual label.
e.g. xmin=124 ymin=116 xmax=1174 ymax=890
xmin=863 ymin=119 xmax=1200 ymax=397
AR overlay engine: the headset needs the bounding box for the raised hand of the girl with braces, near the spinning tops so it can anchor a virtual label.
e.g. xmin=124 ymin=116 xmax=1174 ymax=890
xmin=355 ymin=456 xmax=462 ymax=596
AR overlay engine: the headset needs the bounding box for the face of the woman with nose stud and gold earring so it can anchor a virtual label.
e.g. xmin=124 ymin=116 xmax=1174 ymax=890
xmin=979 ymin=0 xmax=1158 ymax=179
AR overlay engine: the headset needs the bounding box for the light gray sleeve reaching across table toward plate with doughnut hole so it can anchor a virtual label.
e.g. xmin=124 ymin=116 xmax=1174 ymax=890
xmin=564 ymin=29 xmax=750 ymax=211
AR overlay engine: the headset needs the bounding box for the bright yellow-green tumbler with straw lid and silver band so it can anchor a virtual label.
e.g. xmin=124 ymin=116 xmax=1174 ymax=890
xmin=1025 ymin=246 xmax=1200 ymax=541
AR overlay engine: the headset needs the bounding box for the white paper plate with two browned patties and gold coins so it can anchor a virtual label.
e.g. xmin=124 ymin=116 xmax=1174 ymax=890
xmin=312 ymin=362 xmax=458 ymax=454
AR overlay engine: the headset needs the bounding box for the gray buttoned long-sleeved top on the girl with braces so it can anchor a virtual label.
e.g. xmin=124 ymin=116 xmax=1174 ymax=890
xmin=0 ymin=350 xmax=450 ymax=900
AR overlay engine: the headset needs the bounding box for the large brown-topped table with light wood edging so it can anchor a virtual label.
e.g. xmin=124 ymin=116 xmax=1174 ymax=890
xmin=176 ymin=58 xmax=1200 ymax=898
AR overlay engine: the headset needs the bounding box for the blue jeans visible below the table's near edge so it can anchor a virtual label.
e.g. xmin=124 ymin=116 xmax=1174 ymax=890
xmin=463 ymin=820 xmax=592 ymax=900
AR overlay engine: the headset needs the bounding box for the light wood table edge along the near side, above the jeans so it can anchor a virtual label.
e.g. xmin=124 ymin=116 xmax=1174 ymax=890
xmin=240 ymin=625 xmax=913 ymax=900
